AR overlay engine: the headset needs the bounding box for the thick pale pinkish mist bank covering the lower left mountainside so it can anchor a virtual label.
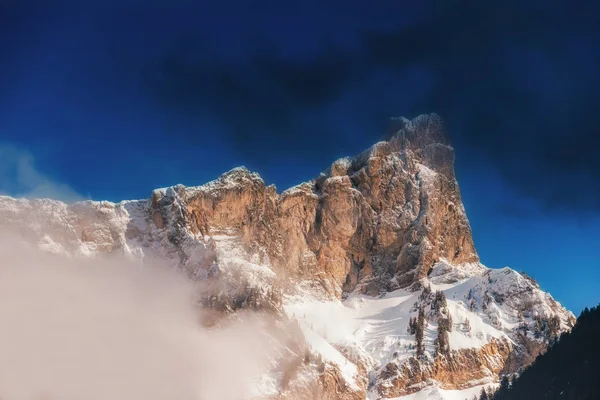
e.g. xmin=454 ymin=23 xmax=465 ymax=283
xmin=0 ymin=232 xmax=269 ymax=400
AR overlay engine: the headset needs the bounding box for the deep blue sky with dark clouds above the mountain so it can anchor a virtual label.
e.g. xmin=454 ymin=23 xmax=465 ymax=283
xmin=0 ymin=0 xmax=600 ymax=312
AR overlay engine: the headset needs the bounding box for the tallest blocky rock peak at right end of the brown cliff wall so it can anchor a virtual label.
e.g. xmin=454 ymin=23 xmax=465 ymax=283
xmin=300 ymin=114 xmax=478 ymax=291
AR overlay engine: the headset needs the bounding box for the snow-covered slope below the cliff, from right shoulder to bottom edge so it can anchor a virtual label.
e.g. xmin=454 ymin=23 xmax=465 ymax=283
xmin=285 ymin=261 xmax=573 ymax=399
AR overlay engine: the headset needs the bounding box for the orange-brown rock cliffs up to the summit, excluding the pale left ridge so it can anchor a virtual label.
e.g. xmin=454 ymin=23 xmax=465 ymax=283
xmin=158 ymin=115 xmax=478 ymax=297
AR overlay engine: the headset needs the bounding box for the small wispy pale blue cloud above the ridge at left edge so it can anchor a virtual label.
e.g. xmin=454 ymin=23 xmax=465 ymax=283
xmin=0 ymin=143 xmax=85 ymax=202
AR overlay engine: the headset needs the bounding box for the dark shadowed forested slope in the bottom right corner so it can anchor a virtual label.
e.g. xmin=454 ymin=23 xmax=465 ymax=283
xmin=493 ymin=307 xmax=600 ymax=400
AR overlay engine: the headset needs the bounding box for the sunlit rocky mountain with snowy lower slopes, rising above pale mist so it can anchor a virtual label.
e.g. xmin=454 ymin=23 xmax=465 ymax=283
xmin=0 ymin=115 xmax=574 ymax=399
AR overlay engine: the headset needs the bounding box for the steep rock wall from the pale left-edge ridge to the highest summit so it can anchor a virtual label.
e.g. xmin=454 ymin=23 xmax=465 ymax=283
xmin=0 ymin=115 xmax=478 ymax=297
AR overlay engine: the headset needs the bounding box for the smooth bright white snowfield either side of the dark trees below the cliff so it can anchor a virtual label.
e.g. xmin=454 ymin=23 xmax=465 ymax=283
xmin=285 ymin=272 xmax=507 ymax=376
